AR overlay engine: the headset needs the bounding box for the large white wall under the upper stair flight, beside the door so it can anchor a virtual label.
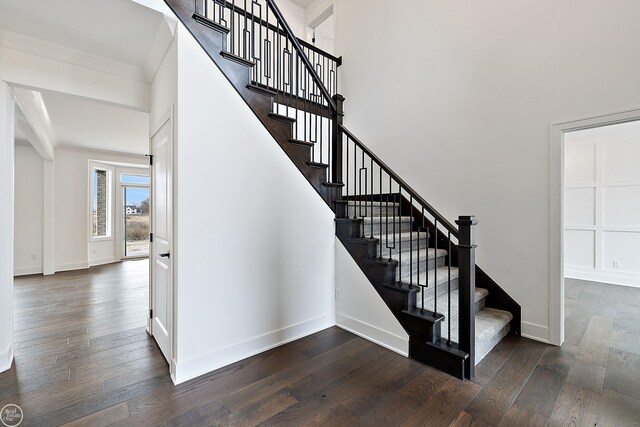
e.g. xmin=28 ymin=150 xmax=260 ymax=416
xmin=172 ymin=26 xmax=335 ymax=382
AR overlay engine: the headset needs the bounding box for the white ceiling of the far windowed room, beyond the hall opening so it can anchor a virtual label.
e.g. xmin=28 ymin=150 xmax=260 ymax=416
xmin=42 ymin=92 xmax=149 ymax=154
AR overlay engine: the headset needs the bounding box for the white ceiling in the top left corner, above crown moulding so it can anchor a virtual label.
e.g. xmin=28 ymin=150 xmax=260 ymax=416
xmin=0 ymin=0 xmax=164 ymax=68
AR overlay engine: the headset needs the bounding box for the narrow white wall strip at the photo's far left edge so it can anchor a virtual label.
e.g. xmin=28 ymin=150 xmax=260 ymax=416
xmin=0 ymin=80 xmax=15 ymax=372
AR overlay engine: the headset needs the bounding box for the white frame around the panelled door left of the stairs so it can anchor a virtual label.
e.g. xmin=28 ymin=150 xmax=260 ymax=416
xmin=147 ymin=104 xmax=177 ymax=383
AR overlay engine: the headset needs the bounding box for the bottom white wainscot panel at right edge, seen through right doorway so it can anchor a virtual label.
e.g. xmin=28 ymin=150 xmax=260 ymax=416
xmin=602 ymin=231 xmax=640 ymax=274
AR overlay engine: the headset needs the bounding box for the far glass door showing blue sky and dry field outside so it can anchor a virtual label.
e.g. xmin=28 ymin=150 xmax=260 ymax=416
xmin=121 ymin=174 xmax=150 ymax=257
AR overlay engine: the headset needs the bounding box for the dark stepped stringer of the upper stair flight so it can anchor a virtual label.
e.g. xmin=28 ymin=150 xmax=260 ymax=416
xmin=165 ymin=0 xmax=341 ymax=209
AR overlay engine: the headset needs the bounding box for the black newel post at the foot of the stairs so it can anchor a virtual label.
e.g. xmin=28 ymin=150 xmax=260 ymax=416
xmin=456 ymin=215 xmax=478 ymax=379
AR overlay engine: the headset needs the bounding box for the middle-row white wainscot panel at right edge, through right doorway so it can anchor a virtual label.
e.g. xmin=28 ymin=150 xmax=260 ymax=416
xmin=602 ymin=185 xmax=640 ymax=227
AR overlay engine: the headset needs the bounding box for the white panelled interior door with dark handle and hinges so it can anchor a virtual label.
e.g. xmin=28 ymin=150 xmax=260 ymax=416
xmin=150 ymin=120 xmax=173 ymax=362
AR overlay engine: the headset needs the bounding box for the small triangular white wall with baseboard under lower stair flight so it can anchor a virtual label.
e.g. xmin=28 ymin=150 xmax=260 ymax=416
xmin=335 ymin=238 xmax=409 ymax=356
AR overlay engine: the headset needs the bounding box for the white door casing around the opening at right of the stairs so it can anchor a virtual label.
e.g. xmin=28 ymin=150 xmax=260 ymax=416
xmin=549 ymin=107 xmax=640 ymax=345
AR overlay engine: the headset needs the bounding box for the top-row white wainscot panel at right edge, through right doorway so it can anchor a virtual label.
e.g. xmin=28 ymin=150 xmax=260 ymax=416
xmin=602 ymin=139 xmax=640 ymax=184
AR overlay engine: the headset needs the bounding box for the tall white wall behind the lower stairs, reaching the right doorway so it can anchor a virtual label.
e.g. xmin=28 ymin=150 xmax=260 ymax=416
xmin=336 ymin=0 xmax=640 ymax=340
